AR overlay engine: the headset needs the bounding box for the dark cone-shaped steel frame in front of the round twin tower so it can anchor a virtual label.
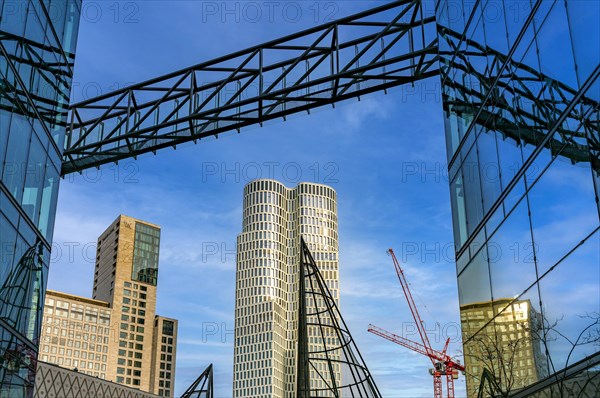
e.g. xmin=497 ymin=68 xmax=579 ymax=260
xmin=296 ymin=239 xmax=381 ymax=398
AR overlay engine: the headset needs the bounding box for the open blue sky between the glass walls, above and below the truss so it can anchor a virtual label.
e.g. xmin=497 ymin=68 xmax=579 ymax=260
xmin=49 ymin=1 xmax=464 ymax=397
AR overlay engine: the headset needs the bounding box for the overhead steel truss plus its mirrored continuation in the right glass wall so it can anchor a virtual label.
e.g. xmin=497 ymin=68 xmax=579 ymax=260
xmin=62 ymin=0 xmax=600 ymax=175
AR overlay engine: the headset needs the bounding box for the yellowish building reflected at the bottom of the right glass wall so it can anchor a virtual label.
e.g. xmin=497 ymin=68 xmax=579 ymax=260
xmin=460 ymin=299 xmax=545 ymax=397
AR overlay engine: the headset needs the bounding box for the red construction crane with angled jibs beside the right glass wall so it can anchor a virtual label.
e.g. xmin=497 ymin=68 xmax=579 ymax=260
xmin=369 ymin=249 xmax=465 ymax=398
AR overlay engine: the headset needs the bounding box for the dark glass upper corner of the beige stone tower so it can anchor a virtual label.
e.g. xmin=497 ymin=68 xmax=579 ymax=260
xmin=131 ymin=223 xmax=160 ymax=286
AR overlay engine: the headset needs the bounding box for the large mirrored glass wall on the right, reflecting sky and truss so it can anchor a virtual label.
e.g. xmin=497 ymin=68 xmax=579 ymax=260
xmin=436 ymin=0 xmax=600 ymax=397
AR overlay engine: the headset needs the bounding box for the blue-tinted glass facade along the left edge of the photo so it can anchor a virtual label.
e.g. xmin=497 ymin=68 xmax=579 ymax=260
xmin=0 ymin=0 xmax=81 ymax=397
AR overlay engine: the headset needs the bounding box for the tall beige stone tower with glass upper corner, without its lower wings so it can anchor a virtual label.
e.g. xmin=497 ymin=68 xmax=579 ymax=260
xmin=92 ymin=215 xmax=160 ymax=391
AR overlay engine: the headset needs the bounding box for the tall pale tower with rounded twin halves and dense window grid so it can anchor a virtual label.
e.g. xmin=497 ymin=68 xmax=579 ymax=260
xmin=233 ymin=180 xmax=341 ymax=398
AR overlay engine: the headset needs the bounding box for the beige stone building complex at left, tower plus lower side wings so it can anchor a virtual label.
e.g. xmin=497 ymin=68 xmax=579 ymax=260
xmin=40 ymin=215 xmax=177 ymax=397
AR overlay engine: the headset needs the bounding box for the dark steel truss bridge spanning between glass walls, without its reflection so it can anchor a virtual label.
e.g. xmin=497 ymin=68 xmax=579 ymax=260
xmin=62 ymin=0 xmax=438 ymax=175
